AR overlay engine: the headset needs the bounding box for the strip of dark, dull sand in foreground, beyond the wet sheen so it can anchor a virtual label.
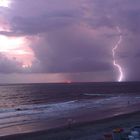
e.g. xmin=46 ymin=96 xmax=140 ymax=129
xmin=0 ymin=111 xmax=140 ymax=140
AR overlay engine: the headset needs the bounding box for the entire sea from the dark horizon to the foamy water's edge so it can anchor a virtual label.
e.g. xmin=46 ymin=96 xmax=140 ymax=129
xmin=0 ymin=82 xmax=140 ymax=136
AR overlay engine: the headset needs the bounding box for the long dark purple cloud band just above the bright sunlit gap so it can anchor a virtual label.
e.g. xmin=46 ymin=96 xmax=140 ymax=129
xmin=12 ymin=12 xmax=79 ymax=35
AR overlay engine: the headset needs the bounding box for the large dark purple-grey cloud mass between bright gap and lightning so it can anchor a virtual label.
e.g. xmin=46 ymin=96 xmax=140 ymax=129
xmin=32 ymin=27 xmax=112 ymax=73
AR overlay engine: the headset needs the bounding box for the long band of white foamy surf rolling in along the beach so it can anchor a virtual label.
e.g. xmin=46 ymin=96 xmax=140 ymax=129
xmin=0 ymin=96 xmax=140 ymax=128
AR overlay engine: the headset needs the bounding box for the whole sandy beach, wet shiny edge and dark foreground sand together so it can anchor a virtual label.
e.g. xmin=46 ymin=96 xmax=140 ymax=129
xmin=0 ymin=104 xmax=140 ymax=140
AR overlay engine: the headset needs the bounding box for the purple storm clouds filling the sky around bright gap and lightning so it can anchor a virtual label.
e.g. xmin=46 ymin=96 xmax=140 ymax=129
xmin=0 ymin=0 xmax=140 ymax=81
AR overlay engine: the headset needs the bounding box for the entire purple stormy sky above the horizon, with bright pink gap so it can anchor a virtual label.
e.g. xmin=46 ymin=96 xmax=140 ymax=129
xmin=0 ymin=0 xmax=140 ymax=83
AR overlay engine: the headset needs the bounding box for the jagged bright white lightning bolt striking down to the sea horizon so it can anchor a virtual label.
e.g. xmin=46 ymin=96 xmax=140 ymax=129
xmin=112 ymin=26 xmax=124 ymax=82
